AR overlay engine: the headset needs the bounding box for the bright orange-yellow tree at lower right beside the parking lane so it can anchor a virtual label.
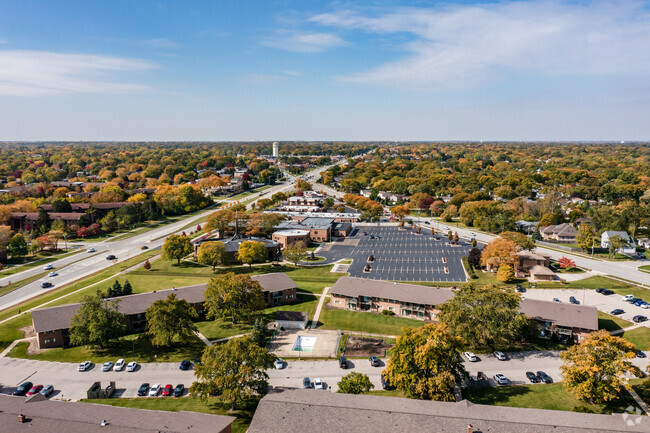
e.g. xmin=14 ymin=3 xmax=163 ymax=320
xmin=560 ymin=329 xmax=640 ymax=403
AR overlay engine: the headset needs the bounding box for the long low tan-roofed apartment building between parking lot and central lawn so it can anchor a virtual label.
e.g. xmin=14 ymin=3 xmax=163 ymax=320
xmin=329 ymin=277 xmax=454 ymax=320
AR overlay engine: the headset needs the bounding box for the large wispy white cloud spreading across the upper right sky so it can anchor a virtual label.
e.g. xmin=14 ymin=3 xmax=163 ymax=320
xmin=311 ymin=1 xmax=650 ymax=90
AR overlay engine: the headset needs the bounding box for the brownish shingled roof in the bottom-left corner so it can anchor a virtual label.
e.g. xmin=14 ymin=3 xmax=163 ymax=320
xmin=0 ymin=394 xmax=235 ymax=433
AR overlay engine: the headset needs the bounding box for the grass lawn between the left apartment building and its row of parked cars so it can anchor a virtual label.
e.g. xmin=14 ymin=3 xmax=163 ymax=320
xmin=9 ymin=334 xmax=205 ymax=364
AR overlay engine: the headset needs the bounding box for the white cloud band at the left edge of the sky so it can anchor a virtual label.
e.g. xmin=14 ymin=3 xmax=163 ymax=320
xmin=0 ymin=50 xmax=155 ymax=96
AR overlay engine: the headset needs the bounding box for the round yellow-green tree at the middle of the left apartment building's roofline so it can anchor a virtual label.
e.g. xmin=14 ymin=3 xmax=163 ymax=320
xmin=204 ymin=272 xmax=266 ymax=324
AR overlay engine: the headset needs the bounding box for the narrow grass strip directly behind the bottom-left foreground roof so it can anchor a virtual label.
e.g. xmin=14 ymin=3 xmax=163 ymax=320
xmin=81 ymin=394 xmax=259 ymax=433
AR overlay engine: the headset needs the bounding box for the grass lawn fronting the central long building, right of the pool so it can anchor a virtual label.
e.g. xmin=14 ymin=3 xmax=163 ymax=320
xmin=319 ymin=308 xmax=424 ymax=335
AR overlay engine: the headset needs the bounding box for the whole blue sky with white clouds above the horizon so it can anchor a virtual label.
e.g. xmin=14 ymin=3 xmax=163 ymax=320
xmin=0 ymin=0 xmax=650 ymax=141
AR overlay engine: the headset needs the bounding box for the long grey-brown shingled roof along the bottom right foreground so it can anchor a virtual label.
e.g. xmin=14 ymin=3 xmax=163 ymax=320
xmin=248 ymin=389 xmax=648 ymax=433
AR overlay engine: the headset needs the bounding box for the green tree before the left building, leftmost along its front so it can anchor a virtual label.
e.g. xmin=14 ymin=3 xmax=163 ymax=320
xmin=70 ymin=291 xmax=126 ymax=347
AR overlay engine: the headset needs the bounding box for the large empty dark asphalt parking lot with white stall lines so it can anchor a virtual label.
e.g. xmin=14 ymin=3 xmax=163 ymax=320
xmin=318 ymin=225 xmax=471 ymax=283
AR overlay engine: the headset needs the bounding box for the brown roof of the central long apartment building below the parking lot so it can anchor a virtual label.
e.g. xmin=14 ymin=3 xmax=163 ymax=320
xmin=330 ymin=277 xmax=454 ymax=305
